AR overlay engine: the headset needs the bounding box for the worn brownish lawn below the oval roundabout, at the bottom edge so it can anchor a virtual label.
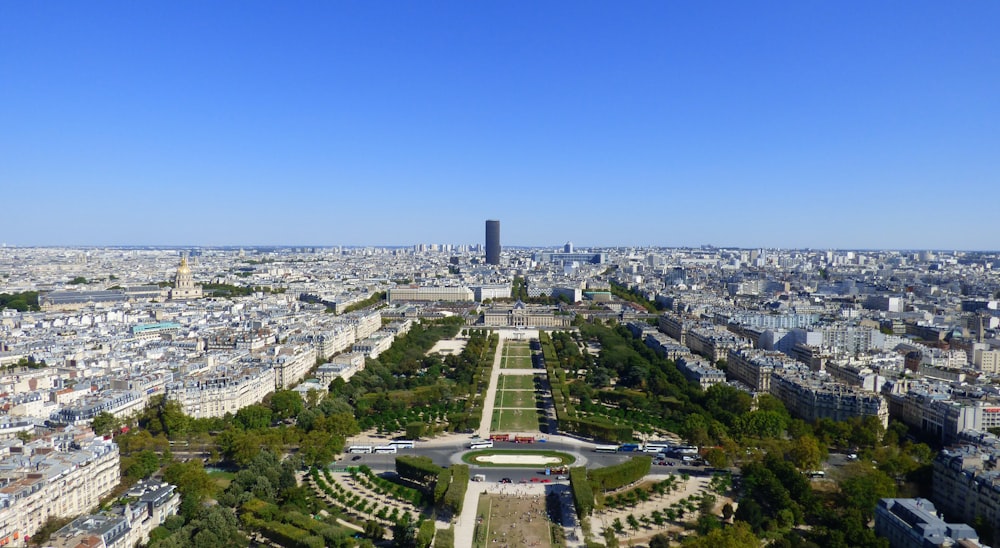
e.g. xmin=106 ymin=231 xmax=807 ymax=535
xmin=473 ymin=493 xmax=552 ymax=548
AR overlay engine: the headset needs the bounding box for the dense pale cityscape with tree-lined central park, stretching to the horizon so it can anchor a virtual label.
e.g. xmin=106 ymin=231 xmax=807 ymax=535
xmin=0 ymin=220 xmax=1000 ymax=548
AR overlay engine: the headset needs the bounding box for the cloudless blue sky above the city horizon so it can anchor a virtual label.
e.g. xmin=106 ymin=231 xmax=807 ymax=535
xmin=0 ymin=0 xmax=1000 ymax=249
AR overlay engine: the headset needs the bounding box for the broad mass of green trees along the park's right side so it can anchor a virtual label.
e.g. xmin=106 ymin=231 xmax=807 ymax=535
xmin=557 ymin=318 xmax=933 ymax=547
